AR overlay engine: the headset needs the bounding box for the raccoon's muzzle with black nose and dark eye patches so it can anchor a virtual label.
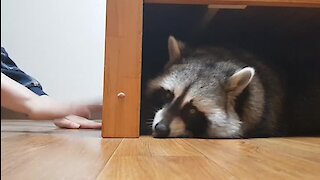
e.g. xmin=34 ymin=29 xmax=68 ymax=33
xmin=152 ymin=87 xmax=209 ymax=137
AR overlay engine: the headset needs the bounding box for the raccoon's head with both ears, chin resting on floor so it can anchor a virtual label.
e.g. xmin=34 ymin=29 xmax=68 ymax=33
xmin=149 ymin=37 xmax=254 ymax=138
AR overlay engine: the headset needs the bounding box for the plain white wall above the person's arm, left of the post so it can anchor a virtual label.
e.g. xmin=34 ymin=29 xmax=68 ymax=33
xmin=1 ymin=0 xmax=106 ymax=101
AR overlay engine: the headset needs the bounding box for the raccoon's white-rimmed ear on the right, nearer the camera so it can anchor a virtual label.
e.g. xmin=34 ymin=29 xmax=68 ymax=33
xmin=226 ymin=67 xmax=255 ymax=96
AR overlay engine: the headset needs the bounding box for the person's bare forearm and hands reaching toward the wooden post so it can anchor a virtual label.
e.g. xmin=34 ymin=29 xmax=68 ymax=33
xmin=1 ymin=73 xmax=101 ymax=128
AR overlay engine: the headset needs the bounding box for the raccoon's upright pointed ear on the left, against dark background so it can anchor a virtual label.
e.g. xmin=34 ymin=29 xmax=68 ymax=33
xmin=168 ymin=36 xmax=185 ymax=62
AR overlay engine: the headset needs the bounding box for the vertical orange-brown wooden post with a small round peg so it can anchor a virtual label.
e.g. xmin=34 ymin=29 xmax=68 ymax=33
xmin=102 ymin=0 xmax=143 ymax=137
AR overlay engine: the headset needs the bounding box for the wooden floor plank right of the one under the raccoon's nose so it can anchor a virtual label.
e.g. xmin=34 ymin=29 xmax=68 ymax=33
xmin=186 ymin=139 xmax=320 ymax=179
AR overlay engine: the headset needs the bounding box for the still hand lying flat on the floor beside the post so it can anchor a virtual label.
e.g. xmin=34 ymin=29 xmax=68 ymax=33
xmin=54 ymin=115 xmax=101 ymax=129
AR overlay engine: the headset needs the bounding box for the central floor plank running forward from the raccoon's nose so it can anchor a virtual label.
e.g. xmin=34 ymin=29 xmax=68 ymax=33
xmin=98 ymin=137 xmax=234 ymax=180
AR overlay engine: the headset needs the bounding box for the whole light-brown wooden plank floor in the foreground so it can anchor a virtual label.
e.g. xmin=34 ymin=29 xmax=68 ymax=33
xmin=1 ymin=120 xmax=320 ymax=180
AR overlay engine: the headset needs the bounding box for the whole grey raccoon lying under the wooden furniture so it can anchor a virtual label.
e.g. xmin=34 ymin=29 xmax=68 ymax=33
xmin=147 ymin=36 xmax=284 ymax=138
